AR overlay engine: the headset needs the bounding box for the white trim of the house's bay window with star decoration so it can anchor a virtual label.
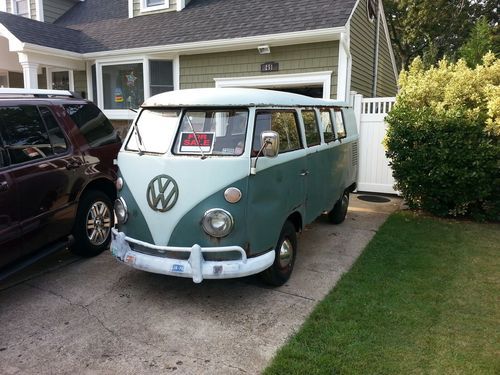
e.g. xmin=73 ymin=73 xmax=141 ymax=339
xmin=94 ymin=56 xmax=180 ymax=120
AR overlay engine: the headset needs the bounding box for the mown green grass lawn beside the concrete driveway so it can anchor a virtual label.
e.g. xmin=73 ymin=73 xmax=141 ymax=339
xmin=265 ymin=211 xmax=500 ymax=375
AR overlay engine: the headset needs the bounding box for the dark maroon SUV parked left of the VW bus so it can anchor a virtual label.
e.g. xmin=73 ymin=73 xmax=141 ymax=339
xmin=0 ymin=89 xmax=121 ymax=268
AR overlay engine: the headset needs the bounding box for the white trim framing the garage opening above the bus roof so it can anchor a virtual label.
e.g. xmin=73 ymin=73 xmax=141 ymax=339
xmin=214 ymin=70 xmax=333 ymax=99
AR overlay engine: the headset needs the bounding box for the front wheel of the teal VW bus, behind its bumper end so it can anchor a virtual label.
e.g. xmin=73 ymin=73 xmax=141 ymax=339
xmin=261 ymin=221 xmax=297 ymax=286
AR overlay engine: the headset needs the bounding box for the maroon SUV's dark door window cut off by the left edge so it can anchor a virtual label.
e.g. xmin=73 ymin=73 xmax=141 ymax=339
xmin=0 ymin=106 xmax=53 ymax=164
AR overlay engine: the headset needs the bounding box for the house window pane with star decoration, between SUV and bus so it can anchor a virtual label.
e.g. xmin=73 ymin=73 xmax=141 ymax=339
xmin=102 ymin=63 xmax=144 ymax=109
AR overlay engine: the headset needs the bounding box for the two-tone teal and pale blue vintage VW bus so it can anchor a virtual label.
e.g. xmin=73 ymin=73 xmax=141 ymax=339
xmin=111 ymin=88 xmax=358 ymax=286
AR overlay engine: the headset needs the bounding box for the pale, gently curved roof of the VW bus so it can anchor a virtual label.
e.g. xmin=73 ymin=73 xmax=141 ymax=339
xmin=142 ymin=88 xmax=347 ymax=107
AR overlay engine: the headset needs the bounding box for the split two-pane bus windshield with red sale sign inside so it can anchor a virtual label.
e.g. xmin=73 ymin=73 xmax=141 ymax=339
xmin=126 ymin=109 xmax=248 ymax=156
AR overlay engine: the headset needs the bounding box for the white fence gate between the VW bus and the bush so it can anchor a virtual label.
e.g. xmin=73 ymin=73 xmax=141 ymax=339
xmin=355 ymin=95 xmax=397 ymax=194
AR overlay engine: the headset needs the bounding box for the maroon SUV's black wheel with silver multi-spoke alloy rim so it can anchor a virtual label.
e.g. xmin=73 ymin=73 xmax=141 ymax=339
xmin=71 ymin=190 xmax=114 ymax=257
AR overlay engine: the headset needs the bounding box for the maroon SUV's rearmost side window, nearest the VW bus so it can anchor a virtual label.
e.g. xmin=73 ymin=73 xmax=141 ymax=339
xmin=64 ymin=103 xmax=120 ymax=147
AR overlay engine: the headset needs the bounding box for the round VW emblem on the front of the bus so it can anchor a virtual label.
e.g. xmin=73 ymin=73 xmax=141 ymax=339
xmin=146 ymin=174 xmax=179 ymax=212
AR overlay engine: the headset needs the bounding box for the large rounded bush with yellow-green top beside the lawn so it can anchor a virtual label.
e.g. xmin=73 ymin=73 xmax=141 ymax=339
xmin=385 ymin=55 xmax=500 ymax=220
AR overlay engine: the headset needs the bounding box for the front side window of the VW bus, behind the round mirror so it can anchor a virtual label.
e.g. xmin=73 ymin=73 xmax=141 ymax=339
xmin=252 ymin=111 xmax=301 ymax=155
